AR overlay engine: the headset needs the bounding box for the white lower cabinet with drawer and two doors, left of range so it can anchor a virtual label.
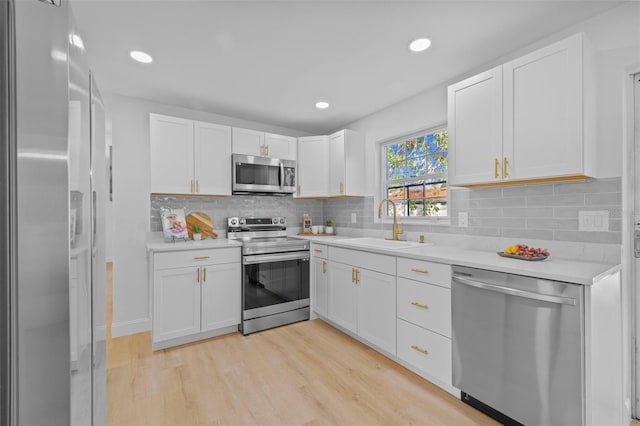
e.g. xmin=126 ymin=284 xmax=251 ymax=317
xmin=151 ymin=247 xmax=241 ymax=350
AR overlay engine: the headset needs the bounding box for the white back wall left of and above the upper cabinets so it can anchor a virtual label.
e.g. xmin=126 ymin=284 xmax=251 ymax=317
xmin=109 ymin=94 xmax=307 ymax=337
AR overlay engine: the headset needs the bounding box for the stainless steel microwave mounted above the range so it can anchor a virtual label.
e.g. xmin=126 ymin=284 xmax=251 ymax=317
xmin=231 ymin=154 xmax=296 ymax=195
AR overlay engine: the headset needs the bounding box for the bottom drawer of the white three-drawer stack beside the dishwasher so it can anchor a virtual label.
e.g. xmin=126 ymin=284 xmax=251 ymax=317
xmin=397 ymin=319 xmax=452 ymax=385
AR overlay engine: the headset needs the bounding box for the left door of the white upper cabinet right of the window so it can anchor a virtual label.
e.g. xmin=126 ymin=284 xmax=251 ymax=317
xmin=448 ymin=66 xmax=502 ymax=185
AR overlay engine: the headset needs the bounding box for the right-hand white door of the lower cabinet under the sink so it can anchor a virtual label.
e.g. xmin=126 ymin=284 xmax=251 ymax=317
xmin=357 ymin=269 xmax=396 ymax=355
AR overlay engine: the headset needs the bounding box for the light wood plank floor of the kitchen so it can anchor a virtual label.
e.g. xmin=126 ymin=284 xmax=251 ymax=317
xmin=107 ymin=267 xmax=497 ymax=426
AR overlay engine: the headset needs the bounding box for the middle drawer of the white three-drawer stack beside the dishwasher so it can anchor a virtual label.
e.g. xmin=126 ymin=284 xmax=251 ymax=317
xmin=397 ymin=278 xmax=451 ymax=337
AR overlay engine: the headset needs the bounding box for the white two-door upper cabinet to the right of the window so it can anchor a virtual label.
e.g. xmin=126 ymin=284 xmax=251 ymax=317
xmin=448 ymin=34 xmax=595 ymax=186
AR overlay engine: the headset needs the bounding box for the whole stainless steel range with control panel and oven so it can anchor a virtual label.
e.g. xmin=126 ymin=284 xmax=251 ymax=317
xmin=227 ymin=217 xmax=309 ymax=335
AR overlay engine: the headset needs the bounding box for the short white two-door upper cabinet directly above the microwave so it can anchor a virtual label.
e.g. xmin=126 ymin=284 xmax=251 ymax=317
xmin=233 ymin=127 xmax=297 ymax=160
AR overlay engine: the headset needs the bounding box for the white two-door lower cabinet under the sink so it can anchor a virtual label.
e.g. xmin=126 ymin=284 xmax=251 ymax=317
xmin=328 ymin=247 xmax=396 ymax=355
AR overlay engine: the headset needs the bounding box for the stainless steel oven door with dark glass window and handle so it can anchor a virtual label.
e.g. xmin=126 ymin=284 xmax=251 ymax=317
xmin=242 ymin=251 xmax=309 ymax=320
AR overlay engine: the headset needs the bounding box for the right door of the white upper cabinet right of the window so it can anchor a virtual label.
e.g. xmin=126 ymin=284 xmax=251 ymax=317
xmin=503 ymin=35 xmax=584 ymax=179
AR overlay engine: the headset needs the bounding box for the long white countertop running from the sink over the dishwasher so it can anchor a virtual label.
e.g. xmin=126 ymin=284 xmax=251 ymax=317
xmin=305 ymin=236 xmax=621 ymax=285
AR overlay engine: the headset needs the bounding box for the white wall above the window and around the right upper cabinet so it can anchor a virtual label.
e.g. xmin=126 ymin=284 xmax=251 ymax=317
xmin=344 ymin=2 xmax=640 ymax=196
